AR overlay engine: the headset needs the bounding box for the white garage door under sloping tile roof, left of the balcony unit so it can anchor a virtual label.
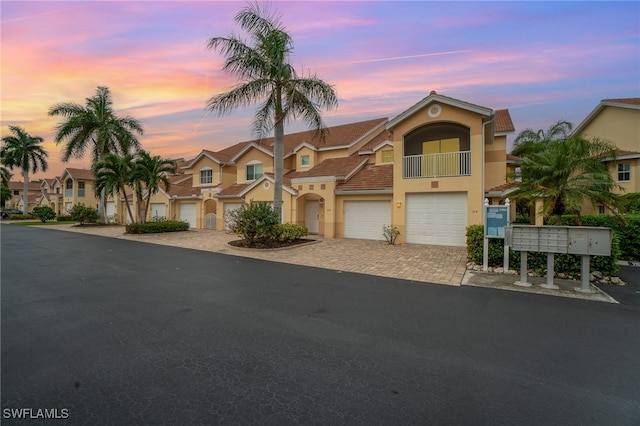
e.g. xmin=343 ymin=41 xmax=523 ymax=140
xmin=344 ymin=201 xmax=391 ymax=240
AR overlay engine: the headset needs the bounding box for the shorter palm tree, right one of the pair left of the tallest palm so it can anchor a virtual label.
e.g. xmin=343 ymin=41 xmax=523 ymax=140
xmin=132 ymin=150 xmax=177 ymax=223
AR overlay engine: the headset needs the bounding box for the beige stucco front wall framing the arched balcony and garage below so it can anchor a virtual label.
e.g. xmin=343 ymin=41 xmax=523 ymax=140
xmin=392 ymin=104 xmax=488 ymax=243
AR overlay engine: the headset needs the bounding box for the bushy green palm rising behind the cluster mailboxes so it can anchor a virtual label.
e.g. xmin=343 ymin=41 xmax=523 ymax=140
xmin=509 ymin=136 xmax=620 ymax=224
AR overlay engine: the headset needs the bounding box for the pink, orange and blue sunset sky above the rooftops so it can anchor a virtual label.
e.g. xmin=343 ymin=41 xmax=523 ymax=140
xmin=0 ymin=0 xmax=640 ymax=180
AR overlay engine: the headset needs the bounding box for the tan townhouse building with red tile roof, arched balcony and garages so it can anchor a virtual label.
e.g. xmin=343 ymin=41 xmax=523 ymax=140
xmin=169 ymin=92 xmax=514 ymax=246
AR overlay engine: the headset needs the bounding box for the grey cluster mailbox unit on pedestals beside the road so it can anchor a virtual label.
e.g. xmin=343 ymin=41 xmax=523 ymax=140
xmin=506 ymin=225 xmax=611 ymax=293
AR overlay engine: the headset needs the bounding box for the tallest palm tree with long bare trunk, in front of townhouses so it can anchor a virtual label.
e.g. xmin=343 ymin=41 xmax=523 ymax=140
xmin=207 ymin=3 xmax=338 ymax=218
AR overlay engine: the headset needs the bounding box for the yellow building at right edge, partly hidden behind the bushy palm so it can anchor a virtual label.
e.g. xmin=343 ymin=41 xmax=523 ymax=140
xmin=573 ymin=98 xmax=640 ymax=214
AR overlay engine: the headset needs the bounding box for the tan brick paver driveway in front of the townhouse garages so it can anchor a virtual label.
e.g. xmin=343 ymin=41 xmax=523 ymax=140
xmin=33 ymin=225 xmax=466 ymax=286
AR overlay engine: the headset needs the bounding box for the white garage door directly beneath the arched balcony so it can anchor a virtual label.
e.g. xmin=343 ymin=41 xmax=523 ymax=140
xmin=406 ymin=192 xmax=467 ymax=246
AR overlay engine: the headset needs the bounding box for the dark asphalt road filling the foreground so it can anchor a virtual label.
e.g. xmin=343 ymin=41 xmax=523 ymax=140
xmin=0 ymin=225 xmax=640 ymax=425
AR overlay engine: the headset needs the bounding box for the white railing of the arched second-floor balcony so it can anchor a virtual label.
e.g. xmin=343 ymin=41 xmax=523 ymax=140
xmin=402 ymin=151 xmax=471 ymax=178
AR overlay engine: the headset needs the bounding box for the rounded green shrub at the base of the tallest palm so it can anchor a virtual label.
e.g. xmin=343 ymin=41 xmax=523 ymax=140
xmin=225 ymin=201 xmax=280 ymax=244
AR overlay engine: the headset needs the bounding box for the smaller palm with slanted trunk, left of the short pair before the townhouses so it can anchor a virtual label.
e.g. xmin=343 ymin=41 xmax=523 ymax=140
xmin=92 ymin=154 xmax=134 ymax=226
